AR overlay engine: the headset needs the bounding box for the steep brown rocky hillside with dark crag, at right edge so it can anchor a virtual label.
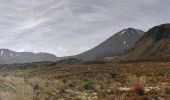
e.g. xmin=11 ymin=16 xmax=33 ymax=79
xmin=124 ymin=24 xmax=170 ymax=58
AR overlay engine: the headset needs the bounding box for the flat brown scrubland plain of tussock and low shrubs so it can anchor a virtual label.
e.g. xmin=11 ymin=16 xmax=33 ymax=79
xmin=0 ymin=62 xmax=170 ymax=100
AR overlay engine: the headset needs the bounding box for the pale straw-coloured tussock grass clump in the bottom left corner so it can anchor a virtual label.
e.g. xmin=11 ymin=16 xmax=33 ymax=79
xmin=0 ymin=76 xmax=34 ymax=100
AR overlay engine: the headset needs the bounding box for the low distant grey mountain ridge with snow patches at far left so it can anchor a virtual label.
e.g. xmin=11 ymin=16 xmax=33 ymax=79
xmin=0 ymin=49 xmax=57 ymax=64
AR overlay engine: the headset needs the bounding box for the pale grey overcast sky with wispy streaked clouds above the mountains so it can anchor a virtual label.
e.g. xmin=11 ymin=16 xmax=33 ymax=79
xmin=0 ymin=0 xmax=170 ymax=56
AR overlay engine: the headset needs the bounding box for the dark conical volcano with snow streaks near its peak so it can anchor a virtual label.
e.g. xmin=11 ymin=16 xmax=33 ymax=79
xmin=72 ymin=28 xmax=144 ymax=60
